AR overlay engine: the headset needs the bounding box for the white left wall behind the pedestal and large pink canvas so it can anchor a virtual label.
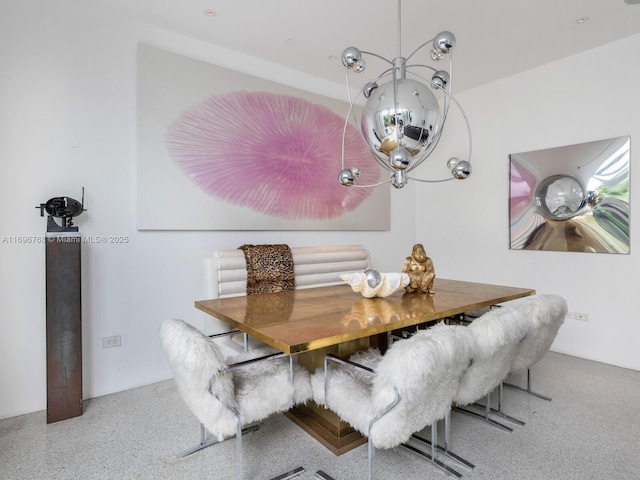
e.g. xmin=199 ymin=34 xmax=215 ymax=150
xmin=0 ymin=0 xmax=415 ymax=418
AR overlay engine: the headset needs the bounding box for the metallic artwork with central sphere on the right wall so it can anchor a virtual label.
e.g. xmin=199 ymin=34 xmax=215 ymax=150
xmin=509 ymin=136 xmax=631 ymax=254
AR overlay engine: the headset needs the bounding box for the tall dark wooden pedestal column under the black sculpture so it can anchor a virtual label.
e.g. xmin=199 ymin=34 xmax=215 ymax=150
xmin=46 ymin=232 xmax=82 ymax=423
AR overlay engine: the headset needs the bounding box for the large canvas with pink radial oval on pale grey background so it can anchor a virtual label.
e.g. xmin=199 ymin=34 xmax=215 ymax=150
xmin=137 ymin=45 xmax=390 ymax=230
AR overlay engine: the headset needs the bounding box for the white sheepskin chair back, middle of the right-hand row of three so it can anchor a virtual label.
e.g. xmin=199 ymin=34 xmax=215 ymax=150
xmin=454 ymin=307 xmax=530 ymax=406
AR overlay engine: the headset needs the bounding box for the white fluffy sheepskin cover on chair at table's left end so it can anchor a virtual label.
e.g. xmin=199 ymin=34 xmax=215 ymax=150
xmin=160 ymin=320 xmax=311 ymax=440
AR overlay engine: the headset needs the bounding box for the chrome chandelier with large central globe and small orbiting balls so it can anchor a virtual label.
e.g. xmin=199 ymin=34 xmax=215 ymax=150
xmin=338 ymin=0 xmax=471 ymax=188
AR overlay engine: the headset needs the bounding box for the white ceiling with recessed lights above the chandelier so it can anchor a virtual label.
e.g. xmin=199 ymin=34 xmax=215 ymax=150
xmin=80 ymin=0 xmax=640 ymax=92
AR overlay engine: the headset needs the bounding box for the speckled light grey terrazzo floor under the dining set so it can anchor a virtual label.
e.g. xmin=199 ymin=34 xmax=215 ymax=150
xmin=0 ymin=352 xmax=640 ymax=480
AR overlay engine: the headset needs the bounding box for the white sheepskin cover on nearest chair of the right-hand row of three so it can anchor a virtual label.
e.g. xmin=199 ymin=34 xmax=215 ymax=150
xmin=312 ymin=324 xmax=473 ymax=448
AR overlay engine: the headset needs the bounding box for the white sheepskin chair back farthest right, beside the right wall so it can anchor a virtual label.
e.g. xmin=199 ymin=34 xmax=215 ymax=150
xmin=511 ymin=294 xmax=567 ymax=372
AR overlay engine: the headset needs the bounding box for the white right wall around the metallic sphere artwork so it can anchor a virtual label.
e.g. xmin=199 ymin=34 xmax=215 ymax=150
xmin=417 ymin=36 xmax=640 ymax=369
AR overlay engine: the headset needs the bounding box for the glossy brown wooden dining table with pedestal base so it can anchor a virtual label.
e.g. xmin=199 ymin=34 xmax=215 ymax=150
xmin=195 ymin=278 xmax=536 ymax=455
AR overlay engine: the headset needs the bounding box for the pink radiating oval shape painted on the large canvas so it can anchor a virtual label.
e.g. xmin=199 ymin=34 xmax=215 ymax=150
xmin=165 ymin=91 xmax=380 ymax=221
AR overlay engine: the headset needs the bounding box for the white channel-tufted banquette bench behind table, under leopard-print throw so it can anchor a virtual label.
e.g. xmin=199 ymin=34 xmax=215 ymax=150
xmin=204 ymin=245 xmax=371 ymax=349
